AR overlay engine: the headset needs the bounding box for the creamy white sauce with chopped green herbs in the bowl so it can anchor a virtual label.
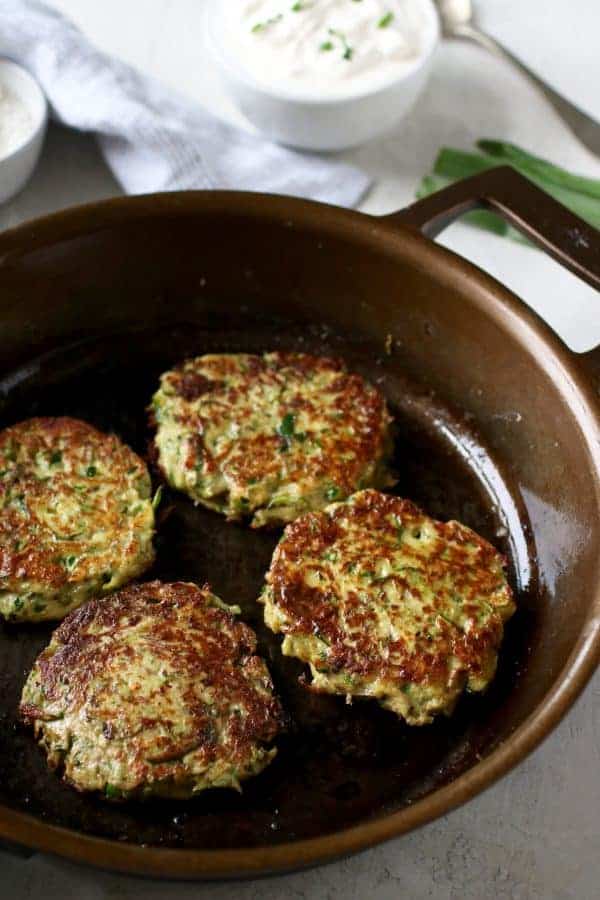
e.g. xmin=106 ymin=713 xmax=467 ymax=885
xmin=221 ymin=0 xmax=437 ymax=99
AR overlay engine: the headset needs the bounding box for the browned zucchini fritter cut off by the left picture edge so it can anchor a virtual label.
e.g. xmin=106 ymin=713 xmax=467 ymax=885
xmin=0 ymin=418 xmax=154 ymax=621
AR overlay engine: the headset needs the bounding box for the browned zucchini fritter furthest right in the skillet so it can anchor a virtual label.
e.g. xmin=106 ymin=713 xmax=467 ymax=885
xmin=260 ymin=490 xmax=515 ymax=725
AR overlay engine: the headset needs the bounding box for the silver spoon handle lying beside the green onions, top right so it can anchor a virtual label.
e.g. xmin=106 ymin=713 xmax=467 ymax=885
xmin=447 ymin=25 xmax=600 ymax=156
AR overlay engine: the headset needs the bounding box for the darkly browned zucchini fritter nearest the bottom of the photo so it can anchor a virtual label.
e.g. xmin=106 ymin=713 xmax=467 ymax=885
xmin=20 ymin=581 xmax=282 ymax=800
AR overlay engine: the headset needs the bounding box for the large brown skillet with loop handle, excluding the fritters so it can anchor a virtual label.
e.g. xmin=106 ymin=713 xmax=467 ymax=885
xmin=0 ymin=169 xmax=600 ymax=878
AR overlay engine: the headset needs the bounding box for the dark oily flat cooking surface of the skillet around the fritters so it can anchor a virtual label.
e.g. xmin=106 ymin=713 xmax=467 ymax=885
xmin=0 ymin=321 xmax=536 ymax=849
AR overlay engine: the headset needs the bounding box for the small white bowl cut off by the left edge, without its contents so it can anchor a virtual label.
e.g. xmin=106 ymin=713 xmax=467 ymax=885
xmin=0 ymin=59 xmax=48 ymax=203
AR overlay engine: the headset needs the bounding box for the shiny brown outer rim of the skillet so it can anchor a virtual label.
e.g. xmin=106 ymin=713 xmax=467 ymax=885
xmin=0 ymin=191 xmax=600 ymax=880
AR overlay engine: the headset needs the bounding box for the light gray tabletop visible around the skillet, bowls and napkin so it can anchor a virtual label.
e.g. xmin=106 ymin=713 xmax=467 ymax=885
xmin=0 ymin=0 xmax=600 ymax=900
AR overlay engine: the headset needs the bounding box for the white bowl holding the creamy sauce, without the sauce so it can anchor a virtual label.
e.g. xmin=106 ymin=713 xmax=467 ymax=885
xmin=204 ymin=0 xmax=440 ymax=151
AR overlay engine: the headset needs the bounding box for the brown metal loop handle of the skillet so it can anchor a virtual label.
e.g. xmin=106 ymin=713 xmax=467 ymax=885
xmin=385 ymin=166 xmax=600 ymax=290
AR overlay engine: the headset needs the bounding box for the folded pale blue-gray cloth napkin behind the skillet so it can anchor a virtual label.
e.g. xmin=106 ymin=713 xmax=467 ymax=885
xmin=0 ymin=0 xmax=369 ymax=206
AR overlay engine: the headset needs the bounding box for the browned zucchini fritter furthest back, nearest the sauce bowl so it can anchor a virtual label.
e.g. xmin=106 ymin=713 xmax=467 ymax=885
xmin=151 ymin=353 xmax=394 ymax=528
